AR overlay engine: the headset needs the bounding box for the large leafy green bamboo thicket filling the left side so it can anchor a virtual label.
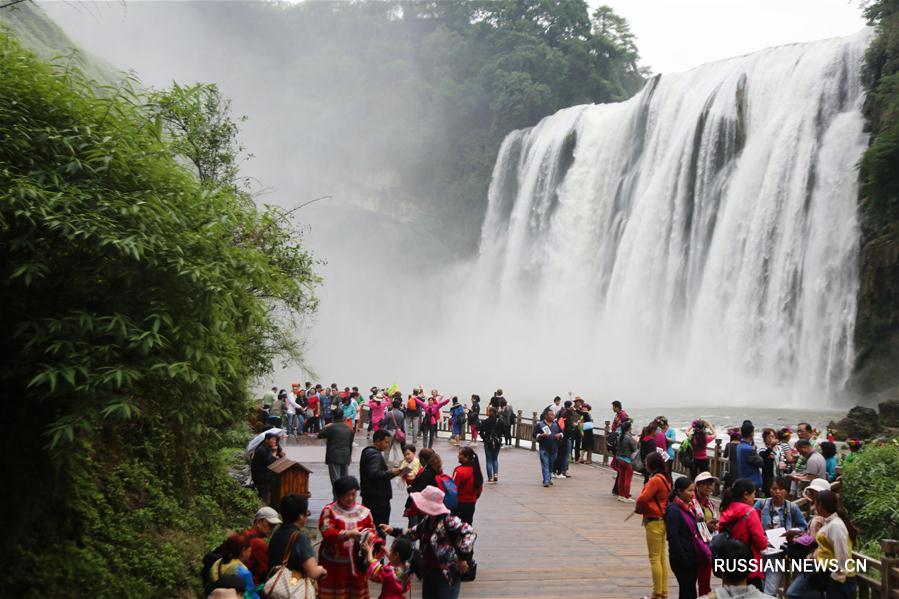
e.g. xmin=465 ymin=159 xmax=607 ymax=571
xmin=0 ymin=33 xmax=318 ymax=597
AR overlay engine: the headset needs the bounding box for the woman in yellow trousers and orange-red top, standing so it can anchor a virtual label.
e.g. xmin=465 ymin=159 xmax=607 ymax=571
xmin=634 ymin=450 xmax=671 ymax=599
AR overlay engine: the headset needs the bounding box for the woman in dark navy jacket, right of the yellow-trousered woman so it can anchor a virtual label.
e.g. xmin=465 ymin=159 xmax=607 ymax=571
xmin=665 ymin=476 xmax=712 ymax=599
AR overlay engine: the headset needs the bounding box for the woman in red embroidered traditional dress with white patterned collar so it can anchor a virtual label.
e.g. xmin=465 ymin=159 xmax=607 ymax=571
xmin=318 ymin=476 xmax=375 ymax=599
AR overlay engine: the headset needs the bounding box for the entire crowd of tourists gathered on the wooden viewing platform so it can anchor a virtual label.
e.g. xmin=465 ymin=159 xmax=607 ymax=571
xmin=214 ymin=383 xmax=861 ymax=599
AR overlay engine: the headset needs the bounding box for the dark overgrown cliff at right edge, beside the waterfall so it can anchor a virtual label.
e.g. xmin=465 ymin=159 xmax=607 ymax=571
xmin=855 ymin=0 xmax=899 ymax=393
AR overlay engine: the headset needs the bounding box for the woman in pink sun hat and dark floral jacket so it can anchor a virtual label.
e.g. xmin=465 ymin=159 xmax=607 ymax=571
xmin=381 ymin=487 xmax=477 ymax=599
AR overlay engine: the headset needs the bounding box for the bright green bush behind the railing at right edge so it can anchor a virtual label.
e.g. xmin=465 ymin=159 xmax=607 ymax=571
xmin=843 ymin=440 xmax=899 ymax=554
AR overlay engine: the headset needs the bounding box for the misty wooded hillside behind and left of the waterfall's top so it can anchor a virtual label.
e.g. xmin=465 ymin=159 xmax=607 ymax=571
xmin=193 ymin=0 xmax=644 ymax=255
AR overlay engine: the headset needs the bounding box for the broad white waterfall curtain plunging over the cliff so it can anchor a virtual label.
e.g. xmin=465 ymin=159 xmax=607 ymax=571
xmin=457 ymin=31 xmax=870 ymax=406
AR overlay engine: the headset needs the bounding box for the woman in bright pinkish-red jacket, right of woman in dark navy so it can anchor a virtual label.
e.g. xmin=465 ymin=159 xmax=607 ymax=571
xmin=718 ymin=478 xmax=768 ymax=591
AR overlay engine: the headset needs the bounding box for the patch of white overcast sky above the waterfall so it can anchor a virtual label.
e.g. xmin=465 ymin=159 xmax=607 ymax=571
xmin=589 ymin=0 xmax=865 ymax=73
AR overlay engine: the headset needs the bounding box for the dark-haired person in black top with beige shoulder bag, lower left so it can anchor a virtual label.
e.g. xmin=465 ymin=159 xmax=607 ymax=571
xmin=266 ymin=493 xmax=328 ymax=590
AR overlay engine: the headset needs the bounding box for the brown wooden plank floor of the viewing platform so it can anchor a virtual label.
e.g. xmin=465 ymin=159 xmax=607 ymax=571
xmin=287 ymin=434 xmax=677 ymax=599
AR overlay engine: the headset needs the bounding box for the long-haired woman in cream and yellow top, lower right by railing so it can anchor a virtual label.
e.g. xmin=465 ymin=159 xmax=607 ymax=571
xmin=787 ymin=491 xmax=858 ymax=599
